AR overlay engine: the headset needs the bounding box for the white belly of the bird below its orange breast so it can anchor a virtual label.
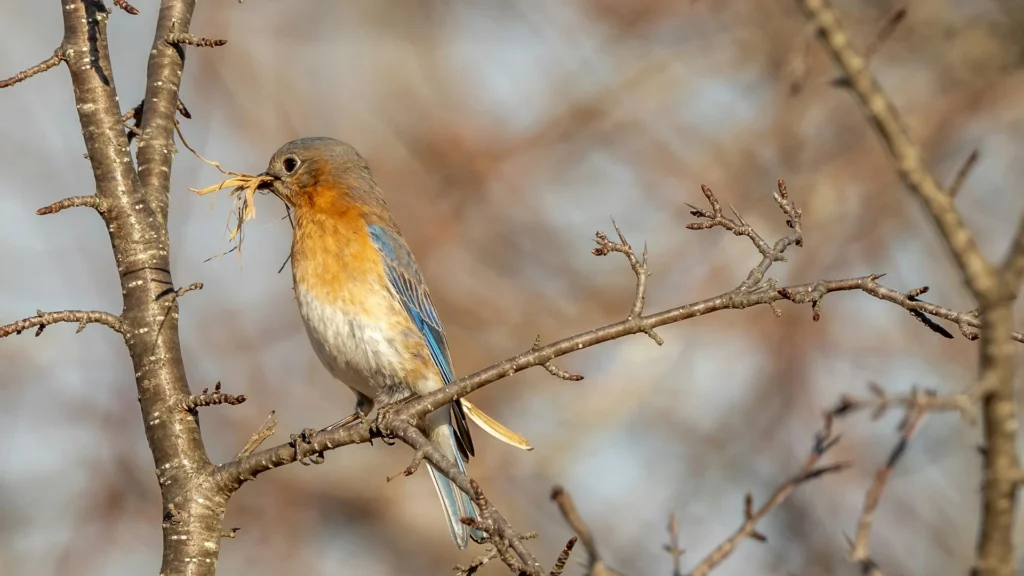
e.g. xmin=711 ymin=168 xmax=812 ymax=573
xmin=295 ymin=288 xmax=408 ymax=401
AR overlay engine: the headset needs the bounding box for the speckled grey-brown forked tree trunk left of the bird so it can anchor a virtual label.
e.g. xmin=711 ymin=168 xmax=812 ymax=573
xmin=60 ymin=0 xmax=226 ymax=576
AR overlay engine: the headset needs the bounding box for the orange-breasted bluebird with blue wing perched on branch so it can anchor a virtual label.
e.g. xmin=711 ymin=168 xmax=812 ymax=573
xmin=260 ymin=136 xmax=532 ymax=548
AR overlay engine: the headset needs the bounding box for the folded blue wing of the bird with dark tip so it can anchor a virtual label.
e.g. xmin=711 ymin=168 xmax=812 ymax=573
xmin=368 ymin=224 xmax=474 ymax=459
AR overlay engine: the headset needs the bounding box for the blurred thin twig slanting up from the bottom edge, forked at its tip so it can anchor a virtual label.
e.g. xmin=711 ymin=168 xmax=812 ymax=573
xmin=690 ymin=415 xmax=849 ymax=576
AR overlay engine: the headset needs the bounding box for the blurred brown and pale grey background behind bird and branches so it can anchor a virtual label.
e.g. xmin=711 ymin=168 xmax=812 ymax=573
xmin=0 ymin=0 xmax=1024 ymax=576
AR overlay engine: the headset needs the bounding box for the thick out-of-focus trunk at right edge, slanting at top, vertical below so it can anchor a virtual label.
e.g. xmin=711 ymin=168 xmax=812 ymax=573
xmin=797 ymin=0 xmax=1024 ymax=576
